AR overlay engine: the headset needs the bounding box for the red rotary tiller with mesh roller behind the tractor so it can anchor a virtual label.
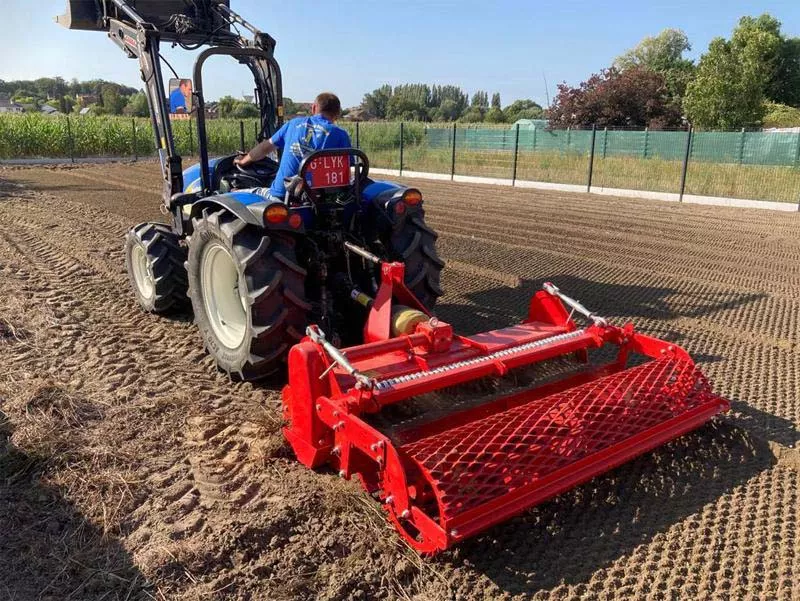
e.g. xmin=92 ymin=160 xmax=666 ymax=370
xmin=283 ymin=258 xmax=729 ymax=553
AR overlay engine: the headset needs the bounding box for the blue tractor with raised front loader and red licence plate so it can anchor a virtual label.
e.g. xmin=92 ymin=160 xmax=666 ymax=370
xmin=57 ymin=0 xmax=444 ymax=380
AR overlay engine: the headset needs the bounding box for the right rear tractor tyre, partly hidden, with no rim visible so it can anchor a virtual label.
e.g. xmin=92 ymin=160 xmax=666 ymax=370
xmin=387 ymin=215 xmax=444 ymax=309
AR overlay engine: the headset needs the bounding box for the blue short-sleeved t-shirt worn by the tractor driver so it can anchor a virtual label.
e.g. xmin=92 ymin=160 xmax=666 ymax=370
xmin=269 ymin=115 xmax=350 ymax=198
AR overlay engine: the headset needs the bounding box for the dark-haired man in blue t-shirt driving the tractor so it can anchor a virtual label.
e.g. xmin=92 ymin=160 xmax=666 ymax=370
xmin=235 ymin=92 xmax=351 ymax=202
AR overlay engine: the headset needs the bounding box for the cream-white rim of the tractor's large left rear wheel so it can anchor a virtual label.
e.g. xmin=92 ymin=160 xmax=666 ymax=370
xmin=200 ymin=242 xmax=247 ymax=349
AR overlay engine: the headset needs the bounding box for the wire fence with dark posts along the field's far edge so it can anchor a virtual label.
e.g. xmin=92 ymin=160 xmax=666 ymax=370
xmin=0 ymin=114 xmax=800 ymax=206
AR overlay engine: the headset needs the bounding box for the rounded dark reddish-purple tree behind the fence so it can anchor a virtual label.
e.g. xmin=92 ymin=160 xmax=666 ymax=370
xmin=549 ymin=66 xmax=681 ymax=128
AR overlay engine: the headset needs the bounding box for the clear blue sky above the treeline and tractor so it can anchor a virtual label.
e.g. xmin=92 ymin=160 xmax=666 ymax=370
xmin=0 ymin=0 xmax=800 ymax=106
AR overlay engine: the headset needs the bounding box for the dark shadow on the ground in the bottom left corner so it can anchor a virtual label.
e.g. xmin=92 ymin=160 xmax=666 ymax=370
xmin=0 ymin=408 xmax=153 ymax=601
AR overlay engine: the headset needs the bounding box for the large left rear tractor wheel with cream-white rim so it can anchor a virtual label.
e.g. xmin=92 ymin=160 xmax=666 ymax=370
xmin=187 ymin=210 xmax=311 ymax=381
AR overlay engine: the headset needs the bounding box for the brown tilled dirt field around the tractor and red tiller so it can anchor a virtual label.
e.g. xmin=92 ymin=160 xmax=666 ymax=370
xmin=0 ymin=163 xmax=800 ymax=600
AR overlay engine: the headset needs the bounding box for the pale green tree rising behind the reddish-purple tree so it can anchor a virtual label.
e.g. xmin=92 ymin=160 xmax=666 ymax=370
xmin=614 ymin=29 xmax=695 ymax=100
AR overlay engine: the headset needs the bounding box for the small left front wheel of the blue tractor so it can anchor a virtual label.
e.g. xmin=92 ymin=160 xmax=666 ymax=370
xmin=125 ymin=223 xmax=187 ymax=313
